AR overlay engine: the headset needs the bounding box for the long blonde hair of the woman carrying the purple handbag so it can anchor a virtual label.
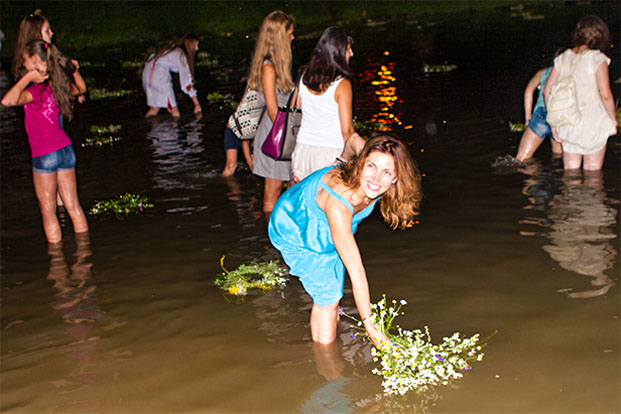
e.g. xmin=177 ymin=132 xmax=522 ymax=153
xmin=246 ymin=10 xmax=295 ymax=93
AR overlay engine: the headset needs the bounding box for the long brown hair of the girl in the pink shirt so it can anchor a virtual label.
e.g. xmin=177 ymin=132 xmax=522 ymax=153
xmin=24 ymin=39 xmax=76 ymax=120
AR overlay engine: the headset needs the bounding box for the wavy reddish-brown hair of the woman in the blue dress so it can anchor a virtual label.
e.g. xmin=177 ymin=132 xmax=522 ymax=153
xmin=335 ymin=135 xmax=423 ymax=230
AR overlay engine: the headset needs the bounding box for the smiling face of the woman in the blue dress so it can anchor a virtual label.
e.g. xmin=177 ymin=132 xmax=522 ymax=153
xmin=360 ymin=151 xmax=397 ymax=199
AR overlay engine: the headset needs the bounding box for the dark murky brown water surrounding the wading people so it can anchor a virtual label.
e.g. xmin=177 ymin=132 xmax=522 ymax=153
xmin=0 ymin=5 xmax=621 ymax=413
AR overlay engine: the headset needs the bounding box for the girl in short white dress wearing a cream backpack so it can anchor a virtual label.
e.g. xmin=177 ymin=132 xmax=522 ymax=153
xmin=544 ymin=16 xmax=617 ymax=171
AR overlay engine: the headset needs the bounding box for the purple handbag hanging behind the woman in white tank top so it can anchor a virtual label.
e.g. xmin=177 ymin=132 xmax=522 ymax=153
xmin=261 ymin=77 xmax=302 ymax=161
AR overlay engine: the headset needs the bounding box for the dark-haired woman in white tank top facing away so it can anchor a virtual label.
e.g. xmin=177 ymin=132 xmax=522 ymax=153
xmin=291 ymin=26 xmax=355 ymax=180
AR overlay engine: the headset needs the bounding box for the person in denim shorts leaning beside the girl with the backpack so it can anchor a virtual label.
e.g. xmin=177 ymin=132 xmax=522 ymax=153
xmin=515 ymin=67 xmax=563 ymax=162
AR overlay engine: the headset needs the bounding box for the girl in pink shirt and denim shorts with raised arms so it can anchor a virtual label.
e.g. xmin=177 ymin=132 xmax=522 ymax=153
xmin=2 ymin=40 xmax=88 ymax=243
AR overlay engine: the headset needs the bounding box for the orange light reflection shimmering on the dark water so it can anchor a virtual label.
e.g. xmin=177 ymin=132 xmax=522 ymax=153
xmin=360 ymin=51 xmax=412 ymax=131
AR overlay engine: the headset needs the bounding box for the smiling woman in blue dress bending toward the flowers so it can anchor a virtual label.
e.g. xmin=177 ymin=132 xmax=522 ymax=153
xmin=268 ymin=135 xmax=422 ymax=344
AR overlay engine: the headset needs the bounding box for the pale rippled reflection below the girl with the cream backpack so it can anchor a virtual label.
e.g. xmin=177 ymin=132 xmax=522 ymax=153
xmin=522 ymin=167 xmax=617 ymax=298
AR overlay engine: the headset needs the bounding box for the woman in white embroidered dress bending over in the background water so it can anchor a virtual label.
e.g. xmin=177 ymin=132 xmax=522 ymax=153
xmin=142 ymin=33 xmax=202 ymax=118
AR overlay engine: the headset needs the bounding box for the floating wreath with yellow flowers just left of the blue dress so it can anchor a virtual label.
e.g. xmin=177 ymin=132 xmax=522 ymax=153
xmin=215 ymin=256 xmax=289 ymax=296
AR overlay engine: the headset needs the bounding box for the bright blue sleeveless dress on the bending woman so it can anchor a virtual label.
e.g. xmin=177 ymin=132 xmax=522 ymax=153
xmin=268 ymin=166 xmax=377 ymax=306
